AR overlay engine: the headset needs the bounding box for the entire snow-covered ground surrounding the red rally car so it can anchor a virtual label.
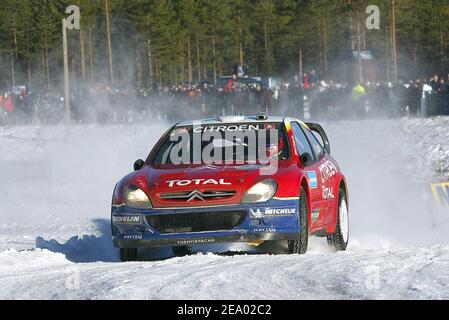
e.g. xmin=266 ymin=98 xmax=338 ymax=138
xmin=0 ymin=118 xmax=449 ymax=299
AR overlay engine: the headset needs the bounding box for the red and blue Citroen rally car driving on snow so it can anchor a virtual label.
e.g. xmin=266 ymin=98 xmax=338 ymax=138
xmin=111 ymin=114 xmax=349 ymax=261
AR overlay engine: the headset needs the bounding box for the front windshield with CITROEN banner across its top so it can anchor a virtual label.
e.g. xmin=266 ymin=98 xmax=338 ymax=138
xmin=152 ymin=123 xmax=289 ymax=165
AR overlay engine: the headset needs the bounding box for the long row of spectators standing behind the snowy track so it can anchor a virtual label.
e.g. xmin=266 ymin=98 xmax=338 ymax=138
xmin=0 ymin=71 xmax=449 ymax=125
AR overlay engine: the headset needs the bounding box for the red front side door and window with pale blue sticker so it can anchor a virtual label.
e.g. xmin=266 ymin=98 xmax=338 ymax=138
xmin=291 ymin=121 xmax=325 ymax=233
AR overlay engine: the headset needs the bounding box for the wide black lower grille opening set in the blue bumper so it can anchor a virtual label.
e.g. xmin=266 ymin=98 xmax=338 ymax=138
xmin=146 ymin=210 xmax=247 ymax=233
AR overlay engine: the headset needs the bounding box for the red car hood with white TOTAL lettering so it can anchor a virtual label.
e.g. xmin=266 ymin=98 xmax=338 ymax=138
xmin=130 ymin=161 xmax=287 ymax=208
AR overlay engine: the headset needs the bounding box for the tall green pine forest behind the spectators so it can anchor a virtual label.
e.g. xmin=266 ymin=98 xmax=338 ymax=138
xmin=0 ymin=0 xmax=449 ymax=90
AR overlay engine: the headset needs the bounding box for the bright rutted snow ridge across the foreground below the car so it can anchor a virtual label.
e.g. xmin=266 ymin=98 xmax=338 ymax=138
xmin=0 ymin=247 xmax=449 ymax=300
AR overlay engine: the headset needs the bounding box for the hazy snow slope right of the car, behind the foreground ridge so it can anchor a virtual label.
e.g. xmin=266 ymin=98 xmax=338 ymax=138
xmin=325 ymin=118 xmax=449 ymax=250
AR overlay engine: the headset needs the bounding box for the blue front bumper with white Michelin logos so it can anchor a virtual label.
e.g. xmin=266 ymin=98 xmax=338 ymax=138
xmin=112 ymin=200 xmax=300 ymax=248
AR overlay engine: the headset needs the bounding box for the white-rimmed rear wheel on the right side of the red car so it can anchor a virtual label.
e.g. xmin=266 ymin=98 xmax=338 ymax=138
xmin=327 ymin=189 xmax=349 ymax=251
